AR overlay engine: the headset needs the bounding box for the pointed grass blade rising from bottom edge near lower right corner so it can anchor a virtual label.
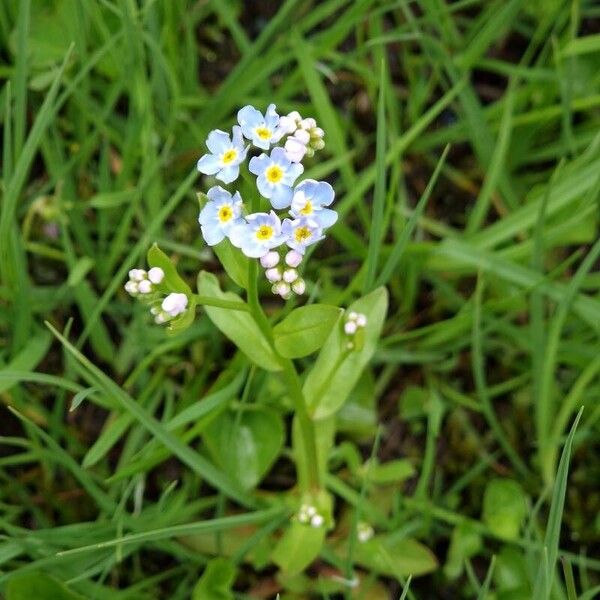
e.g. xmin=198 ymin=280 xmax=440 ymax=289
xmin=532 ymin=407 xmax=583 ymax=600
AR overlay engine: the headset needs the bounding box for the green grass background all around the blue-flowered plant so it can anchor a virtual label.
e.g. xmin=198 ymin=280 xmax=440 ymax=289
xmin=0 ymin=0 xmax=600 ymax=600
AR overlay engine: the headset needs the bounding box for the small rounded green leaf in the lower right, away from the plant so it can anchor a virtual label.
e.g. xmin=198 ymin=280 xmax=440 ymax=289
xmin=482 ymin=479 xmax=527 ymax=540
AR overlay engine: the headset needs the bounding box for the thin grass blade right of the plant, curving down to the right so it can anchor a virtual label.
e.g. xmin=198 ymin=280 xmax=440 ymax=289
xmin=471 ymin=272 xmax=529 ymax=476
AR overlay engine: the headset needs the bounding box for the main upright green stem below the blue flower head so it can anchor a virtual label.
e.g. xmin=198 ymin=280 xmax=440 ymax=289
xmin=248 ymin=253 xmax=322 ymax=492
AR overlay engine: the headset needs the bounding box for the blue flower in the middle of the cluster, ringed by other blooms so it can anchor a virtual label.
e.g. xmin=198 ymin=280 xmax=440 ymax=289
xmin=248 ymin=147 xmax=304 ymax=209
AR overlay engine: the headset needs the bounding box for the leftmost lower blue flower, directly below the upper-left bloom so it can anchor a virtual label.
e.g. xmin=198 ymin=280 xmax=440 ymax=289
xmin=198 ymin=185 xmax=244 ymax=246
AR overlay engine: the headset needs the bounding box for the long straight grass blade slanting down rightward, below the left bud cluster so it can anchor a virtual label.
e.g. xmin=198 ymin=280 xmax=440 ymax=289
xmin=46 ymin=322 xmax=254 ymax=506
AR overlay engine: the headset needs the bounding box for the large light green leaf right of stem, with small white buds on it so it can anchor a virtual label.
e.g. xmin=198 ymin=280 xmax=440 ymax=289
xmin=303 ymin=287 xmax=388 ymax=419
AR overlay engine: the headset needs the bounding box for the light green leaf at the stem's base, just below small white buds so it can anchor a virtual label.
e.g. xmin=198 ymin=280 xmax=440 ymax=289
xmin=272 ymin=521 xmax=325 ymax=575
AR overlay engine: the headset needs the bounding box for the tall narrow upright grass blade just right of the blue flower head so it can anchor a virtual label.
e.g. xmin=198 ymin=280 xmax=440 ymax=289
xmin=363 ymin=60 xmax=387 ymax=295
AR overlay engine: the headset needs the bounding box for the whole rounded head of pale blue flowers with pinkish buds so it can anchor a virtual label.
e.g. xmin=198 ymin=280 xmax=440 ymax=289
xmin=198 ymin=104 xmax=337 ymax=298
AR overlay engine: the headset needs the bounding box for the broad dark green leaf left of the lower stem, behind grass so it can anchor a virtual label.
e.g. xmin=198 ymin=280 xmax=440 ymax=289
xmin=204 ymin=409 xmax=284 ymax=490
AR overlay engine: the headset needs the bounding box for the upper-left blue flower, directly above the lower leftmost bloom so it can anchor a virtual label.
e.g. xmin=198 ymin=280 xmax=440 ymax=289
xmin=198 ymin=125 xmax=248 ymax=183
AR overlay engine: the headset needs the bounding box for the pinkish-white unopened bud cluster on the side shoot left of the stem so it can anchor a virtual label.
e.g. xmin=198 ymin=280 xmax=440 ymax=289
xmin=125 ymin=267 xmax=188 ymax=324
